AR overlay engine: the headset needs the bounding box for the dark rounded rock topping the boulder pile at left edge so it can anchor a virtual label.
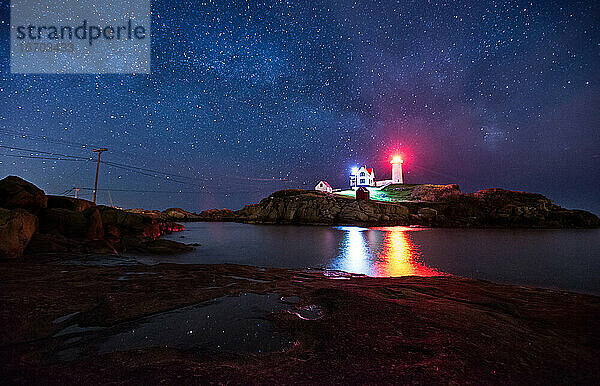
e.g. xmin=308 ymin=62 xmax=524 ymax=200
xmin=0 ymin=176 xmax=47 ymax=214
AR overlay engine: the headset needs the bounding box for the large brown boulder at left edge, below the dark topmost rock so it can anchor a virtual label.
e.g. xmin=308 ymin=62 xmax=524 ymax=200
xmin=0 ymin=208 xmax=37 ymax=258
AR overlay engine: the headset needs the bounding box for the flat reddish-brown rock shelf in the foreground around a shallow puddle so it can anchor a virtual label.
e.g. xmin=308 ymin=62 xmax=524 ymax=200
xmin=0 ymin=259 xmax=600 ymax=385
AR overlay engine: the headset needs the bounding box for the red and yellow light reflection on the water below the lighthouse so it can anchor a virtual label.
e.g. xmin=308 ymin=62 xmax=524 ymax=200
xmin=371 ymin=227 xmax=446 ymax=276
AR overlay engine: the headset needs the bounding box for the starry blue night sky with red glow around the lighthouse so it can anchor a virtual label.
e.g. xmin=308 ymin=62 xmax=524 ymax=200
xmin=0 ymin=0 xmax=600 ymax=213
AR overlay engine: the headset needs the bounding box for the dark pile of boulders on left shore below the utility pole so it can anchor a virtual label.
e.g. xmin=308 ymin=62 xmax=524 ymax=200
xmin=0 ymin=176 xmax=193 ymax=258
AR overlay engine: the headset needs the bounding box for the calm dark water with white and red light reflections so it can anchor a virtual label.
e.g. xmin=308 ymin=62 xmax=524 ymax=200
xmin=156 ymin=223 xmax=600 ymax=294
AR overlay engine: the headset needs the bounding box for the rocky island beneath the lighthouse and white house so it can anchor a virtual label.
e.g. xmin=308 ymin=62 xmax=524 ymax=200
xmin=198 ymin=185 xmax=600 ymax=228
